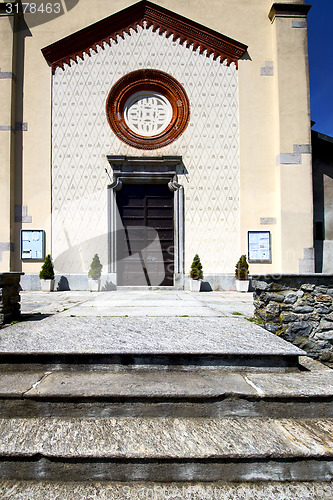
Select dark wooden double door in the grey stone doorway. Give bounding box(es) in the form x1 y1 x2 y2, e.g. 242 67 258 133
117 184 174 286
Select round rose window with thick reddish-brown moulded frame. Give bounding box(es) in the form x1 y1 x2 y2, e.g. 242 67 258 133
106 69 190 149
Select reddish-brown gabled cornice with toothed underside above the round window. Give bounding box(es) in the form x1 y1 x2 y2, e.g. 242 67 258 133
42 0 247 71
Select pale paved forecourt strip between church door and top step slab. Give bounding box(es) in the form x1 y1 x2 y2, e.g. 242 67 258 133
21 290 254 318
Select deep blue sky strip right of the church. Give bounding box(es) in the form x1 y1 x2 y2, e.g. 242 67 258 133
305 0 333 137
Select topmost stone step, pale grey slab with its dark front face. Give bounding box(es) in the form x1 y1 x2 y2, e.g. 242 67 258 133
0 314 305 371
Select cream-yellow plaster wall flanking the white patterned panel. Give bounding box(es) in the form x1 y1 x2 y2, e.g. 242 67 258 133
0 0 313 273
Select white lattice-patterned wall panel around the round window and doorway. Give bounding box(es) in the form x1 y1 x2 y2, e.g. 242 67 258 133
52 27 239 274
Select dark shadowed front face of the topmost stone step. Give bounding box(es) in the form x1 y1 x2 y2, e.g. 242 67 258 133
0 353 300 373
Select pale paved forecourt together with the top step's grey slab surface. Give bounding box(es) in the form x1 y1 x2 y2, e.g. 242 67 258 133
0 290 305 366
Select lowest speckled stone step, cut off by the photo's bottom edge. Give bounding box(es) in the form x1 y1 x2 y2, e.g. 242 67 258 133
0 481 333 500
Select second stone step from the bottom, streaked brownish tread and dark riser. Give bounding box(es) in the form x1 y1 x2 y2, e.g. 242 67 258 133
0 417 333 481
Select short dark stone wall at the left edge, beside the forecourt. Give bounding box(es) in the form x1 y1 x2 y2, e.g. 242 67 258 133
0 273 24 325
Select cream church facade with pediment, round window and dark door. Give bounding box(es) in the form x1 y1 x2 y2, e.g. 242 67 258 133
0 0 315 289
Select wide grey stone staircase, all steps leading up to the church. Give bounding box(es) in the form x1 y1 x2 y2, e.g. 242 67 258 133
0 315 333 499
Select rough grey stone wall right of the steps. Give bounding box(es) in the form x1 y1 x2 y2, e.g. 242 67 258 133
252 274 333 363
